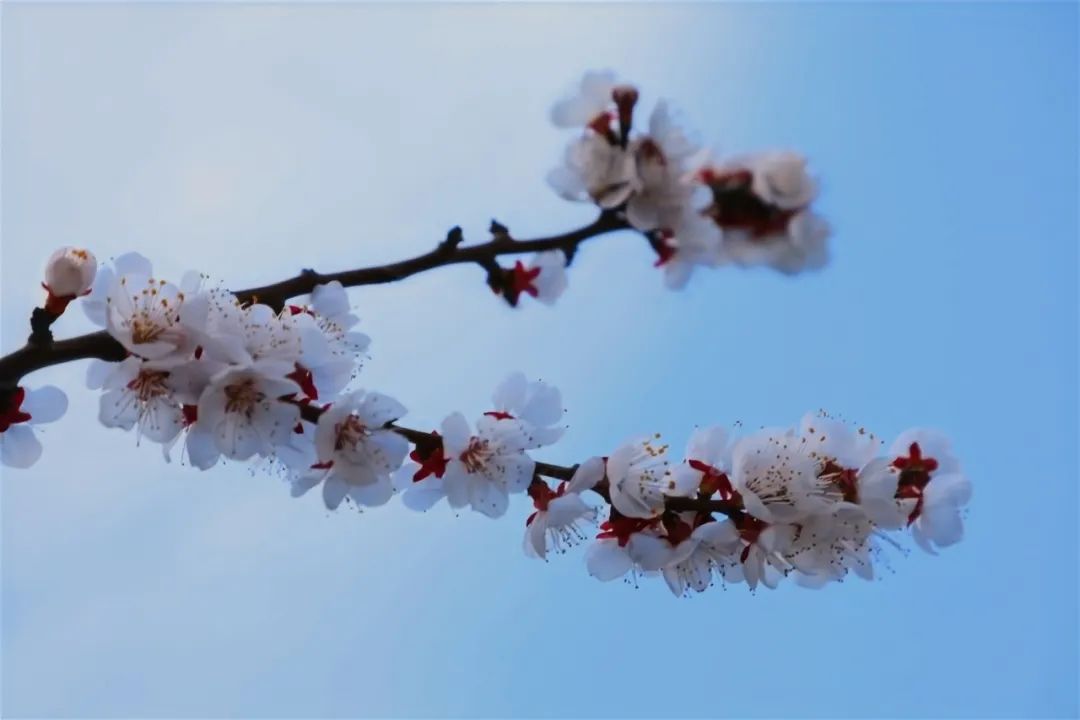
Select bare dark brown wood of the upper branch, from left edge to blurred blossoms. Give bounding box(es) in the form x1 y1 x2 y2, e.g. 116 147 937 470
0 210 631 393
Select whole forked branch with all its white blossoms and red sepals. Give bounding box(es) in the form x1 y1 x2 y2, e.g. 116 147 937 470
0 72 971 595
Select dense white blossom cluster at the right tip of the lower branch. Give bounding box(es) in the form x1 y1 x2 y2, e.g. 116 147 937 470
588 415 971 595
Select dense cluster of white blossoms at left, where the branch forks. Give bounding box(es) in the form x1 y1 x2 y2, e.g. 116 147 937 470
83 253 382 479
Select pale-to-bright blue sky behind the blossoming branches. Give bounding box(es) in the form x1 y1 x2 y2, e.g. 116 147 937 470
0 2 1078 717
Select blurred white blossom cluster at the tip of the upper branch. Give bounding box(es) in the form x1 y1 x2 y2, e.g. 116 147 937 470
548 71 829 288
